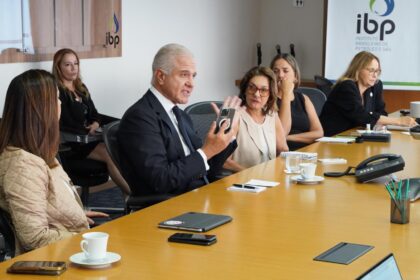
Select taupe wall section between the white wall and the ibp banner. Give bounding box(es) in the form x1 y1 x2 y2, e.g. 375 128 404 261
259 0 324 79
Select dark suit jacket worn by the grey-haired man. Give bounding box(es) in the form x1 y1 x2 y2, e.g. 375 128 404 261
117 91 237 196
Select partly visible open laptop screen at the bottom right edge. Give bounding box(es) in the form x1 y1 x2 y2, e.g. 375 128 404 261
356 253 403 280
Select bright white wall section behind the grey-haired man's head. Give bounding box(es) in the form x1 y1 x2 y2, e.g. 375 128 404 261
0 0 259 117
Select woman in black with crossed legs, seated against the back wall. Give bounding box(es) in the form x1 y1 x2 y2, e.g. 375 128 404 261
52 49 131 196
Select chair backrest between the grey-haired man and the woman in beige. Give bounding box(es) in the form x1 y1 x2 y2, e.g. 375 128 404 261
184 101 223 140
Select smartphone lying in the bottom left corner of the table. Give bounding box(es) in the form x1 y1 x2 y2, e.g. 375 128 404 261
7 261 67 275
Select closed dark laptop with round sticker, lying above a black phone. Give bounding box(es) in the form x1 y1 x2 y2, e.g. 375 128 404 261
158 212 232 232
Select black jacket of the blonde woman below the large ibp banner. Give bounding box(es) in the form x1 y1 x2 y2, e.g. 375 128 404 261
319 80 387 136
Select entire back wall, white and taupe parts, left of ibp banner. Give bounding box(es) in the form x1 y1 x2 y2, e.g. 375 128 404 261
0 0 323 117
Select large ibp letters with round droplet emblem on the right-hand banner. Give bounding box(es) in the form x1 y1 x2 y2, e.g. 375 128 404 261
357 0 395 41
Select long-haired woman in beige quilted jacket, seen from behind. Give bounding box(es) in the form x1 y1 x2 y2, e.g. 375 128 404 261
0 70 107 254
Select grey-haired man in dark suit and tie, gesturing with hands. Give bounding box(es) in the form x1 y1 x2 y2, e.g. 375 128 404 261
117 44 240 196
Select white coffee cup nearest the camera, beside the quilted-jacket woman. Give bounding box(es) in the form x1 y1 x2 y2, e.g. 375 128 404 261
80 232 109 260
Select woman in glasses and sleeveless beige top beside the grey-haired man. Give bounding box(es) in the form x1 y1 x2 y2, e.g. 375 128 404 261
224 67 289 172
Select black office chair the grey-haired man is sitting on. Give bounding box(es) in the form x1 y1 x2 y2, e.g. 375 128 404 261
103 121 173 213
